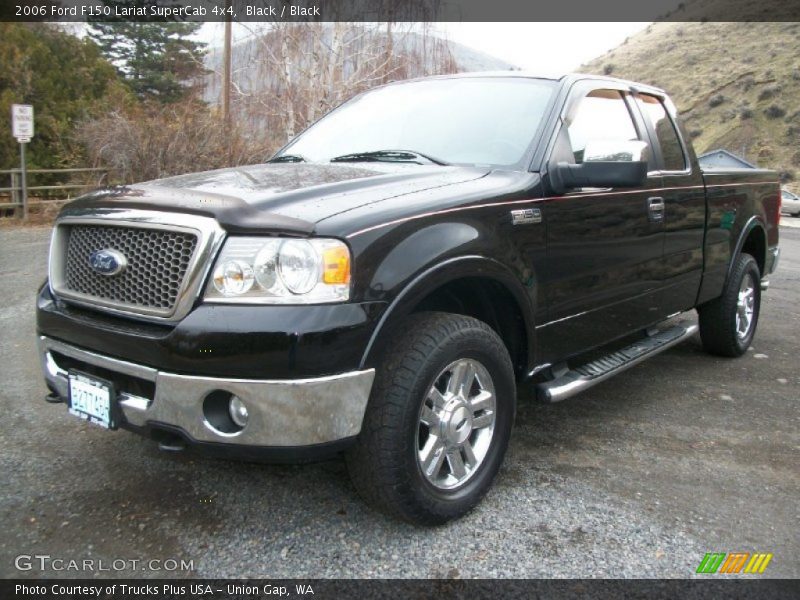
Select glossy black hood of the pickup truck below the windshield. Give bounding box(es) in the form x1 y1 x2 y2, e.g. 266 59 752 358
67 162 490 234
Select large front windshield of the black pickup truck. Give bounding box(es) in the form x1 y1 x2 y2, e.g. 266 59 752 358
281 77 556 165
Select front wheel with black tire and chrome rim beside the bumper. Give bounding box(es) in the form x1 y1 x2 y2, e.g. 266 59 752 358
346 313 516 525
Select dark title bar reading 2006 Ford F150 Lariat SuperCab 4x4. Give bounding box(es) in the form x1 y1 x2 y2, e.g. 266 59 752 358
0 0 800 22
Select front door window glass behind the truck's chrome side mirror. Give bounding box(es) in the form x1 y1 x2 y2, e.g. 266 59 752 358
567 90 639 163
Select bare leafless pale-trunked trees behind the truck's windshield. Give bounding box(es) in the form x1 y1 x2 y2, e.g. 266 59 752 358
216 21 457 142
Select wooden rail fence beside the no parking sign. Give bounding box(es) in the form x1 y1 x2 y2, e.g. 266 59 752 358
0 167 111 218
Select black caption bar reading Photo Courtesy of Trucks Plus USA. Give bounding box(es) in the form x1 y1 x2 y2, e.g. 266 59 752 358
0 578 800 600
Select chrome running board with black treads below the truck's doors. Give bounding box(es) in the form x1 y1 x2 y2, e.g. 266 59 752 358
535 323 698 402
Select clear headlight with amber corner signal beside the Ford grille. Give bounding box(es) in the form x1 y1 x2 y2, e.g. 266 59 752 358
205 237 350 304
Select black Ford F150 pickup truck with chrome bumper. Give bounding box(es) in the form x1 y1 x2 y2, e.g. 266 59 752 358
37 73 780 524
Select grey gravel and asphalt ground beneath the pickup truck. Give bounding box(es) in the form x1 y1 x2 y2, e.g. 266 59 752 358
0 223 800 577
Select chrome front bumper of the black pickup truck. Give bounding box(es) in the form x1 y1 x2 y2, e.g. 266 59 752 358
38 336 375 447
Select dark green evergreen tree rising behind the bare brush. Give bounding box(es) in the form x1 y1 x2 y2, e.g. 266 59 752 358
89 0 205 103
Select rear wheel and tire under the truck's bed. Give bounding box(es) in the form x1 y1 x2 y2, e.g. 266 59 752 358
697 254 761 357
